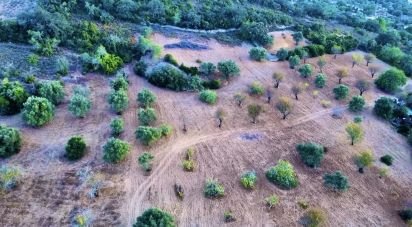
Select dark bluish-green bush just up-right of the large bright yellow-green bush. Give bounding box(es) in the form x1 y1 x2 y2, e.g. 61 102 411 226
296 143 325 168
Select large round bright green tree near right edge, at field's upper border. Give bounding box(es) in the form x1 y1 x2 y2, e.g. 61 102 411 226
375 68 407 93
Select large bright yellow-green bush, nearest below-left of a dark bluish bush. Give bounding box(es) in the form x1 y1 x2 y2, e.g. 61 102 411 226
266 160 299 189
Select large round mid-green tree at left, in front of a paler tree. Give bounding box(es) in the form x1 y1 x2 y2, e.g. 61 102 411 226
22 96 54 127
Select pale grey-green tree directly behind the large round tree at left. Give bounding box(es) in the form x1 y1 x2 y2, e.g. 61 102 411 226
37 80 64 105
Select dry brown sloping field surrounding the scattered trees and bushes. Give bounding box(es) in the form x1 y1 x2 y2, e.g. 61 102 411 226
0 33 412 226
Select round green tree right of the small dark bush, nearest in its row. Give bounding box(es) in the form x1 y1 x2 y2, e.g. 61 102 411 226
103 137 130 163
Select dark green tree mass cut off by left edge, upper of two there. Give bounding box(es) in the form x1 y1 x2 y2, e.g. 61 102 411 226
0 78 29 115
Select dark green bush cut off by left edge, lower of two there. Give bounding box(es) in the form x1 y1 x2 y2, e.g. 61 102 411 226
0 125 21 158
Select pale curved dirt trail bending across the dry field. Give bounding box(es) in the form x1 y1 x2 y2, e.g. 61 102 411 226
127 106 347 226
